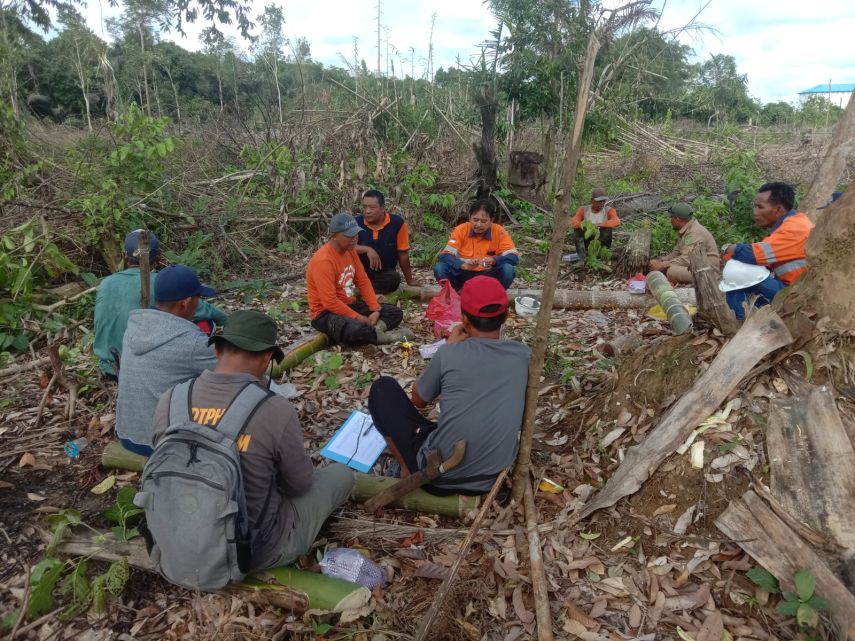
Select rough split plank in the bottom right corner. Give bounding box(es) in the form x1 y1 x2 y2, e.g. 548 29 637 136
715 491 855 639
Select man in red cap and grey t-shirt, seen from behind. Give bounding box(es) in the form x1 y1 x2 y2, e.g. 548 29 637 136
368 276 531 494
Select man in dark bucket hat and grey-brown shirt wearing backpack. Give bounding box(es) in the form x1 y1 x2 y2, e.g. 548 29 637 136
154 310 354 569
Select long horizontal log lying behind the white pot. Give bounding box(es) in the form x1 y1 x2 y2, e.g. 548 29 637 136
403 285 695 309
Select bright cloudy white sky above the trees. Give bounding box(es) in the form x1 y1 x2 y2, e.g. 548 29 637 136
84 0 855 102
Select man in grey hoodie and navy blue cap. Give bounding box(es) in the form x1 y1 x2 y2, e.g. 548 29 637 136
116 265 217 456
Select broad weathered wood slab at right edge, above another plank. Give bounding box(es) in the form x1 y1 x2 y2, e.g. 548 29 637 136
766 387 855 591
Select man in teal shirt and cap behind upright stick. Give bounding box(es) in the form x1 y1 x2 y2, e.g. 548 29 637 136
92 229 227 380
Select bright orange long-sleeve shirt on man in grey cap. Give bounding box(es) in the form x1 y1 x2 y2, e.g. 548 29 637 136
306 243 380 320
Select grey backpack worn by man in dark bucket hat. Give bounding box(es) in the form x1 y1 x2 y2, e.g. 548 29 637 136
134 381 273 591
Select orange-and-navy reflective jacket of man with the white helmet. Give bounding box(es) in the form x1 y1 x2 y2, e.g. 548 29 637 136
724 209 813 285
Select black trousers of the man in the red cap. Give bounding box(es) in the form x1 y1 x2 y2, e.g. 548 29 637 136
368 376 482 496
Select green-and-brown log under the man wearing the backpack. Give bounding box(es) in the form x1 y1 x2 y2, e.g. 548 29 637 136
48 532 371 613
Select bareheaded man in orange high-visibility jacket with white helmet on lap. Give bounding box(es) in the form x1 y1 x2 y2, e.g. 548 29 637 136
722 182 813 319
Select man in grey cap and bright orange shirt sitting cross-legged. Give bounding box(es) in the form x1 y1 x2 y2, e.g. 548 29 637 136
306 213 412 346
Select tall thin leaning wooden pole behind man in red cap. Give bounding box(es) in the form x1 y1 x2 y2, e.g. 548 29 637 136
513 33 600 503
